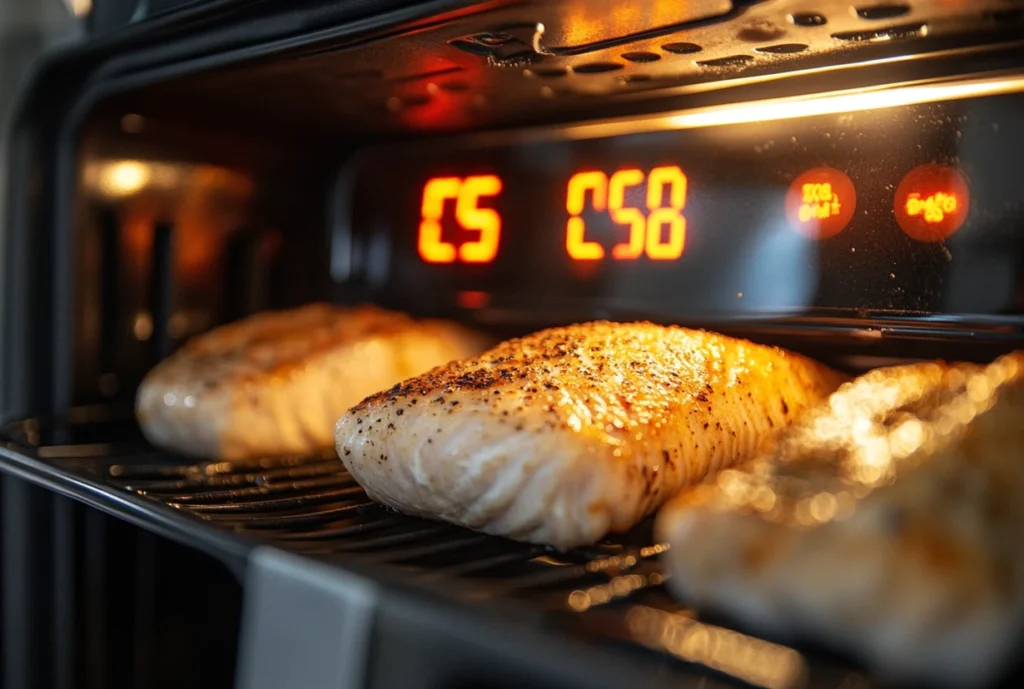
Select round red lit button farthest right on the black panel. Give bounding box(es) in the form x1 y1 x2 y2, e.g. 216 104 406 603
893 163 971 242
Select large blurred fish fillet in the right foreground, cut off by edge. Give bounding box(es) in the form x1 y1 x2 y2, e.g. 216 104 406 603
656 354 1024 686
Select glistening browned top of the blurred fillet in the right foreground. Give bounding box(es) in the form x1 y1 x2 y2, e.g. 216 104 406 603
686 354 1024 528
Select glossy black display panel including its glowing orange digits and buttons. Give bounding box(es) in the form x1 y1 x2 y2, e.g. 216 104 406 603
351 82 1024 317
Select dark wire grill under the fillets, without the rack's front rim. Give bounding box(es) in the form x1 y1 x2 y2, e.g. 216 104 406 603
4 414 873 689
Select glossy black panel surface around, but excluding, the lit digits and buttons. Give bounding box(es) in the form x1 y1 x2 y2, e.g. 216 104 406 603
351 89 1024 319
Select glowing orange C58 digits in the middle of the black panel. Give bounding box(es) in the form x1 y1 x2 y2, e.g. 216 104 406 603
565 166 687 261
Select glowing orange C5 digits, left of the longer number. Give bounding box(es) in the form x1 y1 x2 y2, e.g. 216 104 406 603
417 175 502 263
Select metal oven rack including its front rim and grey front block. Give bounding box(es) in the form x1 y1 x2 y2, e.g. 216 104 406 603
0 411 872 689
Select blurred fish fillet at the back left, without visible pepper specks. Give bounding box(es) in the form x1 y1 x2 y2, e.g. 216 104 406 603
136 304 484 460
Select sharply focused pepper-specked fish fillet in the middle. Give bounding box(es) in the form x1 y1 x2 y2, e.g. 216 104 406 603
336 322 841 548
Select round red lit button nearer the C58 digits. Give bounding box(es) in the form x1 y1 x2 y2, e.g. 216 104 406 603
785 167 857 240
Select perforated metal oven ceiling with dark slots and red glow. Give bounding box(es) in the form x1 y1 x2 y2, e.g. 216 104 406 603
132 0 1024 132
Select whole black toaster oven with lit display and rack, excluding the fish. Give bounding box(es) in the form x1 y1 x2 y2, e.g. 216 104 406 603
0 0 1024 689
